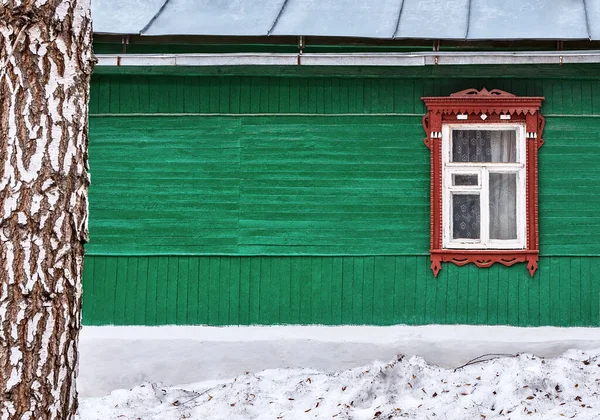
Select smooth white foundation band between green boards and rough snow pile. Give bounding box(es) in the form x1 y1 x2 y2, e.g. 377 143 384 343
78 325 600 398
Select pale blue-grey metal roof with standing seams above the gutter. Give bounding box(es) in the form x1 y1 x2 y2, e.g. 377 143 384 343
92 0 600 40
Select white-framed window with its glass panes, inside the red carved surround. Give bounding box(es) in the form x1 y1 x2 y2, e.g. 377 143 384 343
442 124 526 249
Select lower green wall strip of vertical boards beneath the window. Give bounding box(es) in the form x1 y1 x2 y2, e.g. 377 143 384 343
83 256 600 326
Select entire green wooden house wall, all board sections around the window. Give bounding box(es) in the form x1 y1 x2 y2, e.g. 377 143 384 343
84 67 600 325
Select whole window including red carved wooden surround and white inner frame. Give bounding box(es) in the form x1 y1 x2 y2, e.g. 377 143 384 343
423 89 544 276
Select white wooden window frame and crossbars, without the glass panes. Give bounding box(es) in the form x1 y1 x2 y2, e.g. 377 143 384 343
442 123 527 250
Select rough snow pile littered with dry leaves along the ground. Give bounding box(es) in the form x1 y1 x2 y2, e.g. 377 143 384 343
80 350 600 420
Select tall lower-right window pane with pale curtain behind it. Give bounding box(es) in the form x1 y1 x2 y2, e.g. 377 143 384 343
490 173 517 239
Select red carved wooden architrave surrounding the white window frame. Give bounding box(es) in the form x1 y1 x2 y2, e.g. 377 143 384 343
421 88 544 277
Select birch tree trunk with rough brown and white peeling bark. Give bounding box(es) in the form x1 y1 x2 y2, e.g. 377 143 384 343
0 0 93 420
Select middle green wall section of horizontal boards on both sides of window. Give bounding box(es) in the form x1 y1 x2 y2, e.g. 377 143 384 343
88 111 600 256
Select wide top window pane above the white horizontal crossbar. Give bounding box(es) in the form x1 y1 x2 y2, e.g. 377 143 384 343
452 130 517 163
